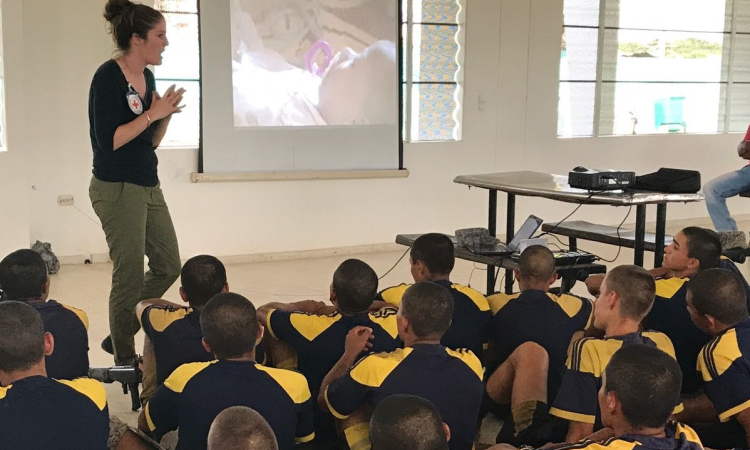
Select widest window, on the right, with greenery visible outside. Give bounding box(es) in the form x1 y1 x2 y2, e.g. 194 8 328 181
557 0 750 137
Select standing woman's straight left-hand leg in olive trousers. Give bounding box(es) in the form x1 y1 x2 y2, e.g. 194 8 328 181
89 178 148 364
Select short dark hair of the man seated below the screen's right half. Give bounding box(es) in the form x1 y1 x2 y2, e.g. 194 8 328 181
333 259 378 313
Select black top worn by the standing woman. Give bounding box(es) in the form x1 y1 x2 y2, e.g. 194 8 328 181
89 60 159 187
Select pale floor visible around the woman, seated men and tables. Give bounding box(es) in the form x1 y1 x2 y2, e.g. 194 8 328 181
44 220 750 442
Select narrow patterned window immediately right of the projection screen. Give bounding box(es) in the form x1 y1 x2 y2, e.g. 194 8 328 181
401 0 466 142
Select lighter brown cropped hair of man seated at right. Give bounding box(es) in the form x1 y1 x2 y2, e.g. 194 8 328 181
606 265 656 322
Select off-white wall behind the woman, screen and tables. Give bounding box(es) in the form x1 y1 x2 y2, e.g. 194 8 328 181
0 0 750 257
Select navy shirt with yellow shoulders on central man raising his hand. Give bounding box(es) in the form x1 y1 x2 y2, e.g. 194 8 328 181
325 344 483 450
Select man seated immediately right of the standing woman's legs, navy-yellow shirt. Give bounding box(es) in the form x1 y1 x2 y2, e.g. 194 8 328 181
135 255 229 404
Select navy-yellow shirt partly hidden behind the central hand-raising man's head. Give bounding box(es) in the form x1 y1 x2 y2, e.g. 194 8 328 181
378 280 492 358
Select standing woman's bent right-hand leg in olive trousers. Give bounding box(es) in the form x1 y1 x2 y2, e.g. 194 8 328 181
140 186 182 300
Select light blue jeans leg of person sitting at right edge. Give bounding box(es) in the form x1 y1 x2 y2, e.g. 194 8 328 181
703 166 750 231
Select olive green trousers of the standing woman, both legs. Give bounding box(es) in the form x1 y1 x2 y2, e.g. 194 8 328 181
89 177 180 364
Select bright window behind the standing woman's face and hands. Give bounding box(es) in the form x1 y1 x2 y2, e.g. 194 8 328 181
154 0 201 148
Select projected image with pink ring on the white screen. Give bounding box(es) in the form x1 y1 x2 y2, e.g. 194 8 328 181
230 0 399 127
